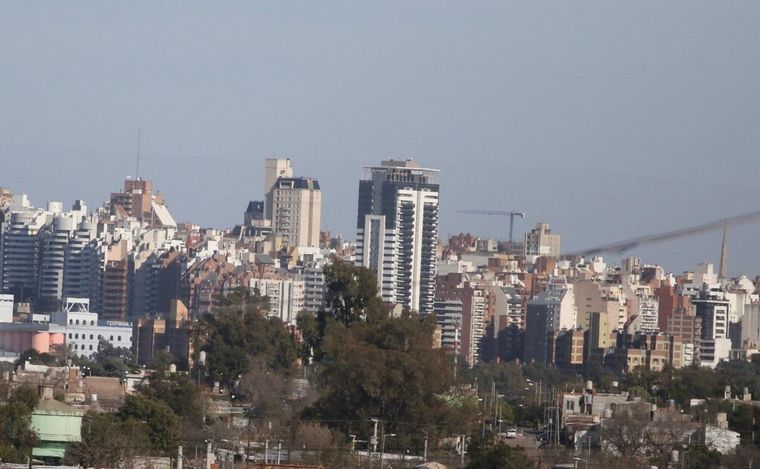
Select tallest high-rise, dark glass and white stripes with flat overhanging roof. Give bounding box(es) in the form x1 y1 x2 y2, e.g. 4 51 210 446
356 160 439 314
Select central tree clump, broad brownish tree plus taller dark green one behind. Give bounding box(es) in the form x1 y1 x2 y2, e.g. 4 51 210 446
306 262 477 444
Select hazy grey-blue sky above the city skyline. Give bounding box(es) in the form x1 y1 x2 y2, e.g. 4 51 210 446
0 0 760 275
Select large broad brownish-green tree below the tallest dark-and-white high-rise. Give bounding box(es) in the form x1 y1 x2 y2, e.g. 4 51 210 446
306 313 477 438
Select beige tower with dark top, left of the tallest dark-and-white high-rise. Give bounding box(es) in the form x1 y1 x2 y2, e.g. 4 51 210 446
268 177 322 247
